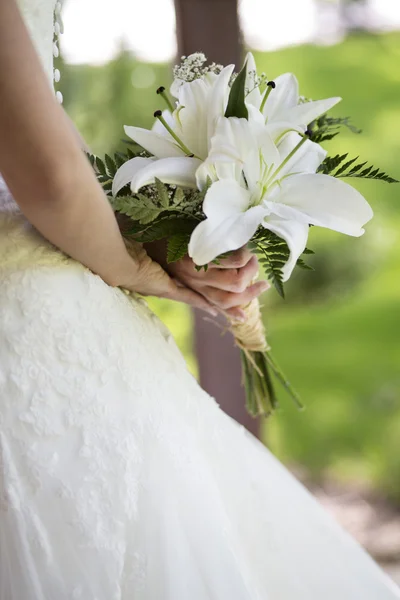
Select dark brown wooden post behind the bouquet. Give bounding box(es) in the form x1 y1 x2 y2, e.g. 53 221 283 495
175 0 259 435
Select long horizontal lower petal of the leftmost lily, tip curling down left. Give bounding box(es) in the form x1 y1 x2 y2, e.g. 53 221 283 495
131 156 201 193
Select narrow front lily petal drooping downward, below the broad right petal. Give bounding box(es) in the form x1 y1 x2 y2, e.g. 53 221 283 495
263 215 309 281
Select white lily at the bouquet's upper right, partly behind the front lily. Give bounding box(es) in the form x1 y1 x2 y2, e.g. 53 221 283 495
246 52 341 132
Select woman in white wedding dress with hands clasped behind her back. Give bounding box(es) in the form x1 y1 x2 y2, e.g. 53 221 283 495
0 0 400 600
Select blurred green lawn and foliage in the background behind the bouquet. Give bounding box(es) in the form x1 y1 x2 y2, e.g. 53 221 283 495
61 32 400 504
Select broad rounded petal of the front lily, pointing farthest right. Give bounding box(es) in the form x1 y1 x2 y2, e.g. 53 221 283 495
269 173 373 237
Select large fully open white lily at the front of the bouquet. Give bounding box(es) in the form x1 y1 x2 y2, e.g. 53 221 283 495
189 118 373 281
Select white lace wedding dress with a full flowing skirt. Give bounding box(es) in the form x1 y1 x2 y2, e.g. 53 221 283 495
0 0 400 600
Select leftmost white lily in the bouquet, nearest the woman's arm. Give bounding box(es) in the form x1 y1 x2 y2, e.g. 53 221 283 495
113 65 234 195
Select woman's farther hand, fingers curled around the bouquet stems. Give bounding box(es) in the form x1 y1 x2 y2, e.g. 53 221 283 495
142 243 269 320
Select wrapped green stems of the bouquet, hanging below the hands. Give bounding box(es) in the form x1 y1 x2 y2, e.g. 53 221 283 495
229 298 302 416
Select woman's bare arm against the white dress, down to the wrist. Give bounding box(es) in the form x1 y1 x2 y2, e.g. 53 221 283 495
0 0 135 285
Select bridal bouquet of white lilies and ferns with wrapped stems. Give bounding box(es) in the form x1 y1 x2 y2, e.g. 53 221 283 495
90 53 395 415
